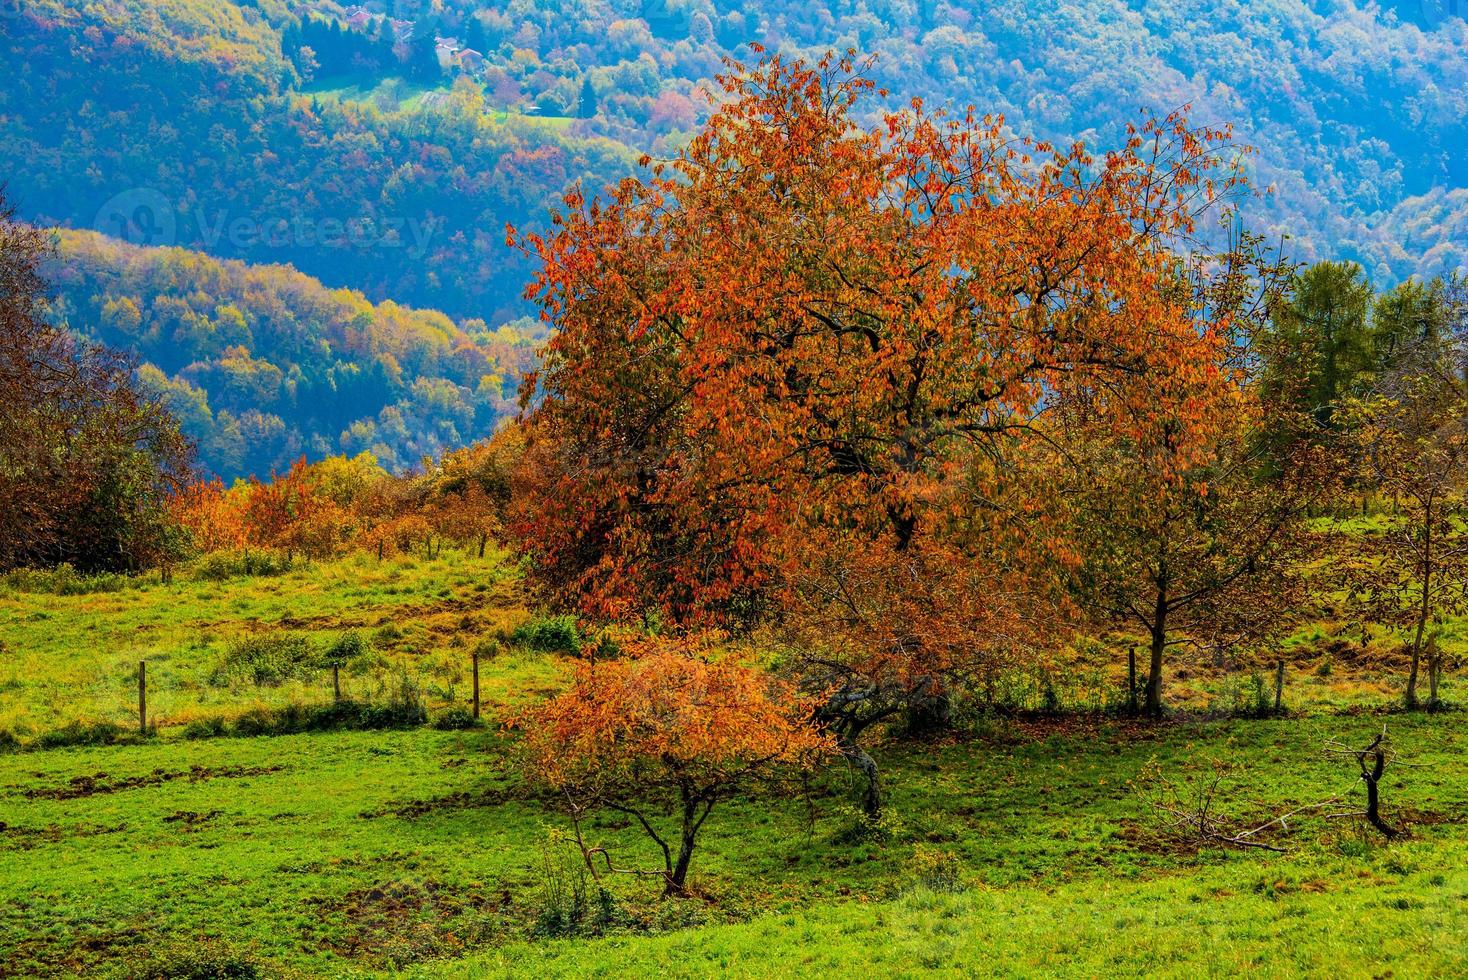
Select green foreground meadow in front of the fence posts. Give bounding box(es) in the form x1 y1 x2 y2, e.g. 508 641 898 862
0 716 1468 976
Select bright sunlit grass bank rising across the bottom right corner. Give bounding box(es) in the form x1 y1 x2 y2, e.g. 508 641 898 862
449 842 1468 977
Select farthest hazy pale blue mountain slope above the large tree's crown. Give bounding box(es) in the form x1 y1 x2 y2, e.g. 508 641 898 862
390 0 1468 285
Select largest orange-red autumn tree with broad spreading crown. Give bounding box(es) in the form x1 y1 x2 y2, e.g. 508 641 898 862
511 47 1262 808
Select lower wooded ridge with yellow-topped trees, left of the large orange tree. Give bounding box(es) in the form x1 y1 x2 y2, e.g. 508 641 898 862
46 230 534 478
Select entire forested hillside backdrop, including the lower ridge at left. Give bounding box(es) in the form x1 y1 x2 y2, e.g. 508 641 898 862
0 0 1468 475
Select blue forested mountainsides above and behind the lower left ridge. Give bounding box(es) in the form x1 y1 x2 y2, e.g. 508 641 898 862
0 0 1468 303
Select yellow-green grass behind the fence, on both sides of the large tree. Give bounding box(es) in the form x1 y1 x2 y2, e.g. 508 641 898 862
0 550 1444 738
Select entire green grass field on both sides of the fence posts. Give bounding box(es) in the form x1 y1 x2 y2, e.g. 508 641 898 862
0 555 1468 977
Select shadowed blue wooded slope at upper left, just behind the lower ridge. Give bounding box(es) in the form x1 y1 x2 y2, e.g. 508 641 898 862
0 0 634 323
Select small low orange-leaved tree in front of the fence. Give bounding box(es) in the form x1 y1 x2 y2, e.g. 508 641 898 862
515 638 831 895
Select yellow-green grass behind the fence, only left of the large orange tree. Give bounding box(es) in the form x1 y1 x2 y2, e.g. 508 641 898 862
0 549 534 735
